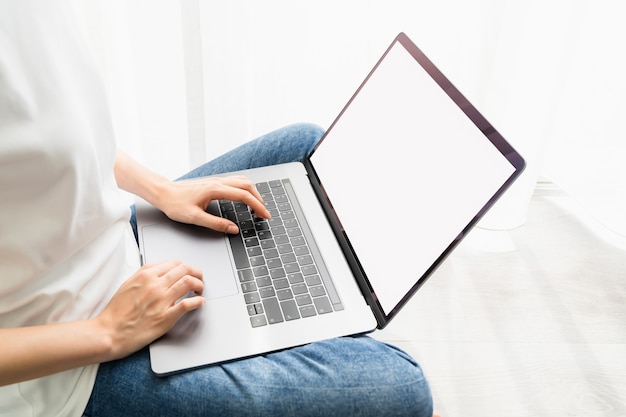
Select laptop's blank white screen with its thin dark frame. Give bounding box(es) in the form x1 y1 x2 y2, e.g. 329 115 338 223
310 34 523 320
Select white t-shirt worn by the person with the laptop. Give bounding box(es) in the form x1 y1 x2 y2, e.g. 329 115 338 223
0 0 139 417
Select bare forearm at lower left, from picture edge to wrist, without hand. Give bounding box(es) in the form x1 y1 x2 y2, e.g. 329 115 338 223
0 320 113 386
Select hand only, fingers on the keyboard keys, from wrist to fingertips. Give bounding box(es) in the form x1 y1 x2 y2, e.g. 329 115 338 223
152 176 270 234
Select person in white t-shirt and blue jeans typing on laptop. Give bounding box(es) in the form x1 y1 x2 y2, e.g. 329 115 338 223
0 0 432 417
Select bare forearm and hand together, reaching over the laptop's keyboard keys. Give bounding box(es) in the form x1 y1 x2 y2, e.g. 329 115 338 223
115 151 270 233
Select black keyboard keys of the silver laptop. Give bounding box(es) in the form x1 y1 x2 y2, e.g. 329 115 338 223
214 179 343 327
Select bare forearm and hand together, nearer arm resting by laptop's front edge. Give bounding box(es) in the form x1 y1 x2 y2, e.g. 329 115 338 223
0 261 204 386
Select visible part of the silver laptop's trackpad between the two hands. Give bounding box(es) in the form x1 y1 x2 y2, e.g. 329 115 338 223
142 222 238 299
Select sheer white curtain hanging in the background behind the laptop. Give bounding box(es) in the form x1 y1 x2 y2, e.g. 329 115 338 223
77 0 626 237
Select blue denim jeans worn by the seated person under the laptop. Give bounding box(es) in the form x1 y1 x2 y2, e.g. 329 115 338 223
85 124 432 417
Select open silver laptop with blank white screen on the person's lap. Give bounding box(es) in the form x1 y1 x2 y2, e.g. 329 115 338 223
136 33 524 375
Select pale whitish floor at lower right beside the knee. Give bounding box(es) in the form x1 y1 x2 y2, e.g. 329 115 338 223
374 186 626 417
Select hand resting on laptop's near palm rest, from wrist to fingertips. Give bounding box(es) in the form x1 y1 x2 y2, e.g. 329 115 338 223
95 261 204 359
